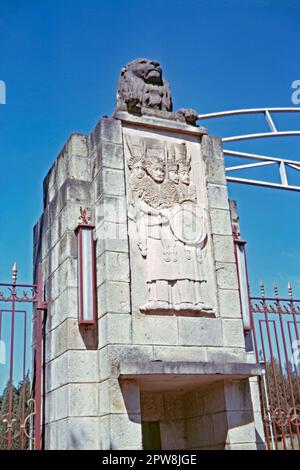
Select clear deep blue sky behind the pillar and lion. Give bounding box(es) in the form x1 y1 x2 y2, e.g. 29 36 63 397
0 0 300 297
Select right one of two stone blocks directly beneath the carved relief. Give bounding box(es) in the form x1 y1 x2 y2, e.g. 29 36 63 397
178 317 223 346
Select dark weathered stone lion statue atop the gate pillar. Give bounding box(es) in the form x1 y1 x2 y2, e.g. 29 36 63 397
116 59 197 125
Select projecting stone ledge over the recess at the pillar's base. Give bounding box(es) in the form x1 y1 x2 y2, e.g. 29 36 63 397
119 361 261 391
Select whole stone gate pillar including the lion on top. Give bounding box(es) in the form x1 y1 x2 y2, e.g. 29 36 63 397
35 59 264 450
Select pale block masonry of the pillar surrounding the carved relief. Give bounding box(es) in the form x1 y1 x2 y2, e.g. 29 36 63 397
34 118 259 449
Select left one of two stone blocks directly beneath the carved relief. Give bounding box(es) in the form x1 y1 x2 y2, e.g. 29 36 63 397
132 315 178 345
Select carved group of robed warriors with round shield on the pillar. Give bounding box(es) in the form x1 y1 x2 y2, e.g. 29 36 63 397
126 138 212 313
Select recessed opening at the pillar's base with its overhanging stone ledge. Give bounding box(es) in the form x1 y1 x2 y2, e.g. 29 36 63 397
115 361 264 450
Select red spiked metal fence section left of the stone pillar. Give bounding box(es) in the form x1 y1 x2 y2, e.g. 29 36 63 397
0 265 47 450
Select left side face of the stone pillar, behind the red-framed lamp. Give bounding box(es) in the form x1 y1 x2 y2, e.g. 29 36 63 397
34 134 99 449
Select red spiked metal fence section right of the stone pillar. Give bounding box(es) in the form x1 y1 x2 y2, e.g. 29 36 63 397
250 284 300 450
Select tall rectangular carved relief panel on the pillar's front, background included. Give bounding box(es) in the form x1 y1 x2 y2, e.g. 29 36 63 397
124 130 214 316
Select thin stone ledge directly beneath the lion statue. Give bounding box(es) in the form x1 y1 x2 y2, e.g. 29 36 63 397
114 111 207 137
